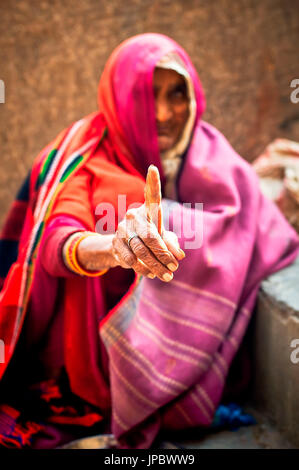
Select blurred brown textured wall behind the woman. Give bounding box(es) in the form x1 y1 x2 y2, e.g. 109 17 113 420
0 0 299 228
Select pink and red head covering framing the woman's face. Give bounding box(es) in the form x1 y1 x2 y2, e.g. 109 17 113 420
98 33 205 182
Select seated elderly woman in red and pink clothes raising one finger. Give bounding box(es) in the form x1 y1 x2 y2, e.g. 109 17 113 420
0 34 299 448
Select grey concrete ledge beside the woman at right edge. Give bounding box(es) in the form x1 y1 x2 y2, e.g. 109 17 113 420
253 258 299 447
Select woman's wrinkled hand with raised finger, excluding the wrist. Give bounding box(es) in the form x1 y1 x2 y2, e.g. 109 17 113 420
112 165 185 282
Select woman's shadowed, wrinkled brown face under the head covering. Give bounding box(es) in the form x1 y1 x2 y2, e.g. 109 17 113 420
154 67 189 152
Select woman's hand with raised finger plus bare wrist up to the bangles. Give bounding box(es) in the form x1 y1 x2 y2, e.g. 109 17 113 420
73 165 185 282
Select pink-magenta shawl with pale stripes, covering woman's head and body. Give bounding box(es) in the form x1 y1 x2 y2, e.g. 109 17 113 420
95 34 299 447
